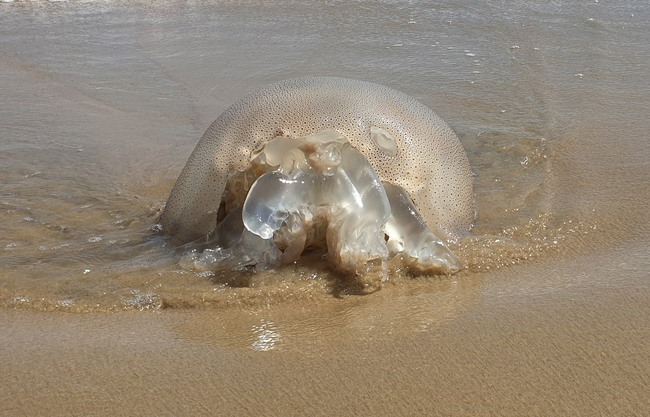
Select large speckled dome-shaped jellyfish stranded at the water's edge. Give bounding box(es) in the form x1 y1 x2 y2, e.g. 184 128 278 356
160 77 474 275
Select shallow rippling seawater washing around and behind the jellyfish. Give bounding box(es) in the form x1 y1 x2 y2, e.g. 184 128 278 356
0 1 650 316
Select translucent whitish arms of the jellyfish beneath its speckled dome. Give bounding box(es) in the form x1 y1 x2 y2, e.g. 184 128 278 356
184 130 459 275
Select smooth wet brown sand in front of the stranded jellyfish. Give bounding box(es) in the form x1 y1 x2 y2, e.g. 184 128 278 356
0 239 650 416
